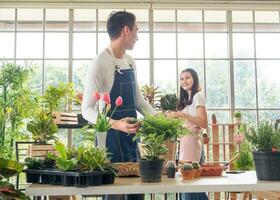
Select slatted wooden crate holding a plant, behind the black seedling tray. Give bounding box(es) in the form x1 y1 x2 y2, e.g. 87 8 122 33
27 144 54 158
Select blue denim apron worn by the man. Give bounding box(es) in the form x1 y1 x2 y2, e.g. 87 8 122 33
105 49 144 200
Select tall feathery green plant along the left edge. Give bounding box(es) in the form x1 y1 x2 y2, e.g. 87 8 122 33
0 62 36 157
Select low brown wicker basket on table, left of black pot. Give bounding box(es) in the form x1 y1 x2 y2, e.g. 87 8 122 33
113 162 140 176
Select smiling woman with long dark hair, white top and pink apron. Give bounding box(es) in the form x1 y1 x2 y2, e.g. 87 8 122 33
167 68 208 200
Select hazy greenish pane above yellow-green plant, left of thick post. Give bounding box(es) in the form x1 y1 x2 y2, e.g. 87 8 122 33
45 60 68 88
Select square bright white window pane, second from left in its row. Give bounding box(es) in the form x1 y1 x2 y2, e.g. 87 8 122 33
16 33 43 58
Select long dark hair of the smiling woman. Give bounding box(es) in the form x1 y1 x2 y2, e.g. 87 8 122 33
178 68 199 110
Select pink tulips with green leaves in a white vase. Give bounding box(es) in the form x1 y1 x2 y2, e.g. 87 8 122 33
93 92 123 148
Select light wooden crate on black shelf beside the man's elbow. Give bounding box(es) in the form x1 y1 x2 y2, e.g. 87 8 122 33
52 111 78 124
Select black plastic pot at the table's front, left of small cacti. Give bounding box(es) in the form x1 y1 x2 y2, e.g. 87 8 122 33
138 159 164 182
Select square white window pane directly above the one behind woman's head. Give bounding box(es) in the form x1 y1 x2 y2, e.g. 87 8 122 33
178 33 203 58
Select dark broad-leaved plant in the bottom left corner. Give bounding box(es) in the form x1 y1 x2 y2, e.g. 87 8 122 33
0 158 30 200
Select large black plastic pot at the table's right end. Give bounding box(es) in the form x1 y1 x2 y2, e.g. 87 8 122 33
253 151 280 181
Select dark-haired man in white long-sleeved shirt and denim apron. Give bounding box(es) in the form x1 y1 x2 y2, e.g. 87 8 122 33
82 11 156 200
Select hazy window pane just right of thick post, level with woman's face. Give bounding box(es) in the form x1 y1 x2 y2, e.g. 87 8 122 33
234 60 256 108
